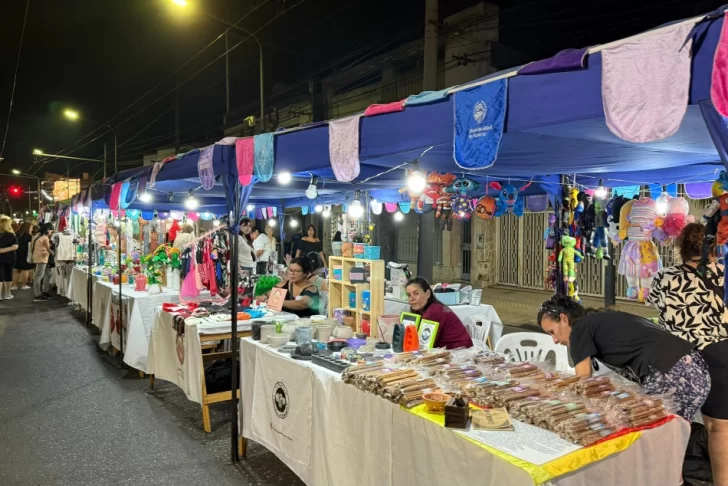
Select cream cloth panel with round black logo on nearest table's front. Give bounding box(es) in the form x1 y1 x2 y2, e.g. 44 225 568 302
251 349 314 466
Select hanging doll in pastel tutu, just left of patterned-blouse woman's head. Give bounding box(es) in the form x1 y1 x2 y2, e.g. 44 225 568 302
617 198 664 302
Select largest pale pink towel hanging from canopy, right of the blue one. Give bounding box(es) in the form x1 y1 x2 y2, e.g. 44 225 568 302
602 23 694 143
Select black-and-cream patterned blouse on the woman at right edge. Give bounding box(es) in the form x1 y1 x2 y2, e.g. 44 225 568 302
647 263 728 349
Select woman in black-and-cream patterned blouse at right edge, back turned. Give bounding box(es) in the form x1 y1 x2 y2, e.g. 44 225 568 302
647 223 728 486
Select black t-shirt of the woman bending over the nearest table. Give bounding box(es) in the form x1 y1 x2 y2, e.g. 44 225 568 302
569 312 695 379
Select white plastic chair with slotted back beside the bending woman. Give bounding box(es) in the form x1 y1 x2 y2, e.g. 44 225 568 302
495 332 572 371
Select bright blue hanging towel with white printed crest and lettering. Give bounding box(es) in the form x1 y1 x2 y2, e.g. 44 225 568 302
453 79 508 169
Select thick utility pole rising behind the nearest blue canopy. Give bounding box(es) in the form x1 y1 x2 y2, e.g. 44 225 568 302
417 0 438 281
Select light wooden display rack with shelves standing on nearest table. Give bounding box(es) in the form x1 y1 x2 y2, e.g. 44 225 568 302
329 256 384 337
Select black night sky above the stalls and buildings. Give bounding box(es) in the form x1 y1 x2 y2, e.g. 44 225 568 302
0 0 723 203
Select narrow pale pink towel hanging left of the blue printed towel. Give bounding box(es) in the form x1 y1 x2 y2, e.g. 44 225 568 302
329 115 361 182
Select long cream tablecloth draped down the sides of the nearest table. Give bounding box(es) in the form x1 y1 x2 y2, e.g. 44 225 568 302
240 338 690 486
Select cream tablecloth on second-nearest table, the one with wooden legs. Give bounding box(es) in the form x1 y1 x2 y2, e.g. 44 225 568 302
149 306 297 403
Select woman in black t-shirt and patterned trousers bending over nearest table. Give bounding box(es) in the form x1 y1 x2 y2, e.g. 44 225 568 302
538 295 710 421
